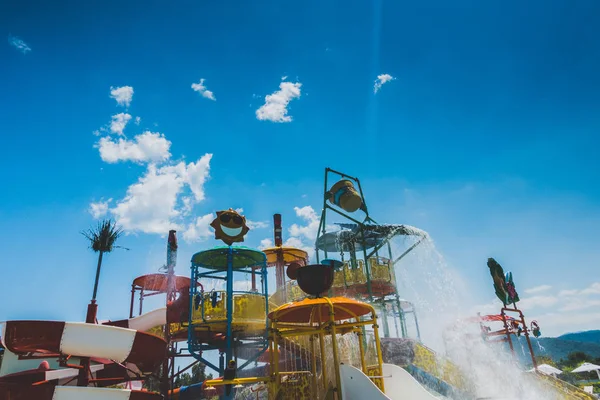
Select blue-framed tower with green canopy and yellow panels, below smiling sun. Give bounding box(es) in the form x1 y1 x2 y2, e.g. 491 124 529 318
188 246 269 398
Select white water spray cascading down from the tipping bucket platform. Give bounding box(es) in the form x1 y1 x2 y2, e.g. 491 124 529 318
393 238 558 400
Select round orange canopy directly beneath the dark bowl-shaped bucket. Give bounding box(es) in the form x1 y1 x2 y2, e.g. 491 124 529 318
269 297 375 323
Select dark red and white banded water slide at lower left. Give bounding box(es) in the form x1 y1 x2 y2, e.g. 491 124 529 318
0 320 166 400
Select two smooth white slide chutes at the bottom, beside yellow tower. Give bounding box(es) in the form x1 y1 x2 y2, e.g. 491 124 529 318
340 364 439 400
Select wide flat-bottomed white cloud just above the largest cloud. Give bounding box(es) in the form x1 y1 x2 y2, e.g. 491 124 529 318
95 131 171 163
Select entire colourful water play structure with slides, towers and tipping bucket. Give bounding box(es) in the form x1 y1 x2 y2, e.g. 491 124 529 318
0 168 586 400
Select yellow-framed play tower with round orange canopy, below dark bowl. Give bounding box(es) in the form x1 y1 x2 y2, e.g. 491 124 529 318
205 297 384 400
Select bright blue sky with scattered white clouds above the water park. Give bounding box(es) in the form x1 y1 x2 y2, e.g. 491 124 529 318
0 0 600 344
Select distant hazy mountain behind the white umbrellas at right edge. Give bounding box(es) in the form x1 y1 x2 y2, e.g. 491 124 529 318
508 331 600 365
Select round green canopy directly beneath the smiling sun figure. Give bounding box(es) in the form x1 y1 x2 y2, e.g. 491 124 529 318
192 246 266 270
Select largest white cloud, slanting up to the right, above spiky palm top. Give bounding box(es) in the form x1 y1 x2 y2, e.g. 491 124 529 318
110 154 212 234
